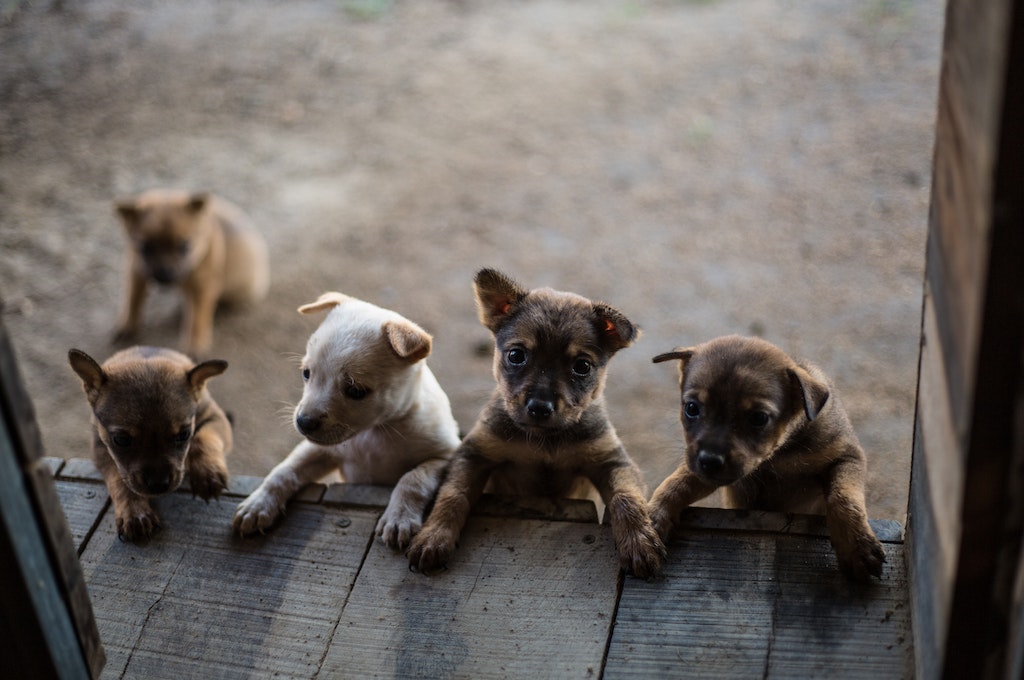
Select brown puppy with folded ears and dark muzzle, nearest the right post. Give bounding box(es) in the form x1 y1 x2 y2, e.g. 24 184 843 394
650 336 886 581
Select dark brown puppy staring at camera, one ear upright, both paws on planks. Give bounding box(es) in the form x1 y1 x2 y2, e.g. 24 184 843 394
408 269 665 578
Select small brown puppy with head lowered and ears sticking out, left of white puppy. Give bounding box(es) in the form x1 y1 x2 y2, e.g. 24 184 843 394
68 347 231 542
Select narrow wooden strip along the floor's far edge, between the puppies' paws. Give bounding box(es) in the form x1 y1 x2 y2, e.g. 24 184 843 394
45 458 905 544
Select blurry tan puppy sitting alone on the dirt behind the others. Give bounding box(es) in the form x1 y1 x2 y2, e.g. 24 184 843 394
115 189 270 356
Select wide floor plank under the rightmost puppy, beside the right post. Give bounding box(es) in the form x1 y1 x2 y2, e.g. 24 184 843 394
604 532 913 679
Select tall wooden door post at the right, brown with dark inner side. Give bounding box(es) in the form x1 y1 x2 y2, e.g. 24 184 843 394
908 0 1024 678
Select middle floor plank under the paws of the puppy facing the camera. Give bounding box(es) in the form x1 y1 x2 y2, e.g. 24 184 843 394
321 516 618 678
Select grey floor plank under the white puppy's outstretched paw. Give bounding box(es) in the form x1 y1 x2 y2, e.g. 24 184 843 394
82 494 377 679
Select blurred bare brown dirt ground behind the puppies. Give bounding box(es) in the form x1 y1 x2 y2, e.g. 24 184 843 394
0 0 942 520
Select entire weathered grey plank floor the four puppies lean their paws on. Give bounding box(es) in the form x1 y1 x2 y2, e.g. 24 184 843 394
50 460 913 680
